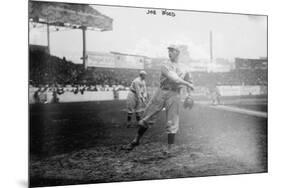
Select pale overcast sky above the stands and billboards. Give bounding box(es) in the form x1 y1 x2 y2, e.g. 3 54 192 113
30 5 267 63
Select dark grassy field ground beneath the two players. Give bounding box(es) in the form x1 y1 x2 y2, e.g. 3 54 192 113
30 101 267 186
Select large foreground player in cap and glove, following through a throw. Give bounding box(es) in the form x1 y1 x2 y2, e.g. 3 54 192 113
126 45 193 153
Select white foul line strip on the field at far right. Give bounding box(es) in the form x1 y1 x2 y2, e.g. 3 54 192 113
210 105 267 118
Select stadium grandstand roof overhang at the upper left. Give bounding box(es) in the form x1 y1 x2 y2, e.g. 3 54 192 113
29 1 113 31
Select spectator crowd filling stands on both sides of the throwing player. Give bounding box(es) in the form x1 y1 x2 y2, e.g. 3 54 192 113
29 50 267 98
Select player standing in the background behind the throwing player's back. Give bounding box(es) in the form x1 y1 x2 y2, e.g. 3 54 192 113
127 70 147 128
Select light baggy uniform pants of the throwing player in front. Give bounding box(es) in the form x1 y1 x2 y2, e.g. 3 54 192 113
142 88 180 134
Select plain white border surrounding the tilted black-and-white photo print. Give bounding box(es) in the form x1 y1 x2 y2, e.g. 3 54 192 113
0 0 281 188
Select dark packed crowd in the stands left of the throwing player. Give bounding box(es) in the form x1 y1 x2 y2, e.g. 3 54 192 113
29 50 160 90
